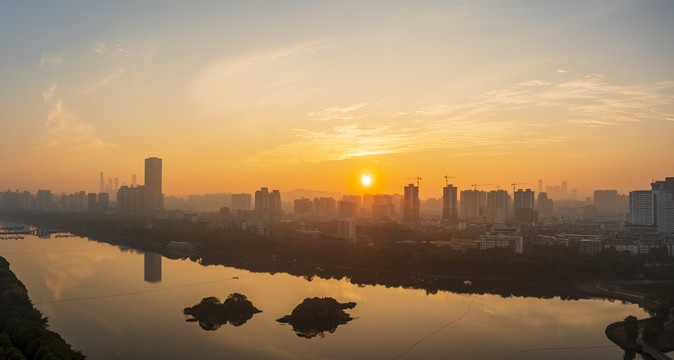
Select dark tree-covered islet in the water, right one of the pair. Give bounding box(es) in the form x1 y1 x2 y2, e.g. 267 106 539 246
276 297 356 339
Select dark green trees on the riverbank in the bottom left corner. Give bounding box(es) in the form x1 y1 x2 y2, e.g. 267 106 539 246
0 257 84 359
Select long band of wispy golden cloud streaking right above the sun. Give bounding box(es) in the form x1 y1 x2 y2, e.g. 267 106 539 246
244 75 674 166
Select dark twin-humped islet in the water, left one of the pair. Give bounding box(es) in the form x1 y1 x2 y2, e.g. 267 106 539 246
183 293 262 331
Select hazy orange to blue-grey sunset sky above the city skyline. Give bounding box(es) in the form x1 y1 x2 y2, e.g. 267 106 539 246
0 0 674 198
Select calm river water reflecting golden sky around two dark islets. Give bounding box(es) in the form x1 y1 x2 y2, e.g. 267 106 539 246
0 221 660 360
